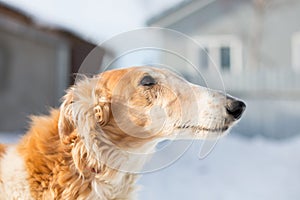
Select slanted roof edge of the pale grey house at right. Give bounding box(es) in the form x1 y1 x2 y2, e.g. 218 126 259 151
147 0 216 27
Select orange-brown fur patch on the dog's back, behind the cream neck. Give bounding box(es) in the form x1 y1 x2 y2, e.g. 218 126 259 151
18 110 89 199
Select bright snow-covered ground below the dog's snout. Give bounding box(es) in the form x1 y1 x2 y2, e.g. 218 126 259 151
0 134 300 200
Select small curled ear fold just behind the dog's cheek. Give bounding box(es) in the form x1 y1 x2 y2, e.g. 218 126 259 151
93 89 110 126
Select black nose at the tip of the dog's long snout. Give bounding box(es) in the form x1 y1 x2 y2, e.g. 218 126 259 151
225 96 246 120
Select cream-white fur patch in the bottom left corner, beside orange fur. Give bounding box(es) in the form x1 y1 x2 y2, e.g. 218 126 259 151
0 146 33 200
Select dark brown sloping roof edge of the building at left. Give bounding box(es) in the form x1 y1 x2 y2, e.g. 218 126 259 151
0 2 95 45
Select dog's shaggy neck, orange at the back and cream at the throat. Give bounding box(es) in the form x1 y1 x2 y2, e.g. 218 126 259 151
19 110 141 199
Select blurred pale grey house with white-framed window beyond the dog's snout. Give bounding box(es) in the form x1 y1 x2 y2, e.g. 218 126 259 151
148 0 300 138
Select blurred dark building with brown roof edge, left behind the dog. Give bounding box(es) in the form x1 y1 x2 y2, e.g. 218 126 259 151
0 4 104 132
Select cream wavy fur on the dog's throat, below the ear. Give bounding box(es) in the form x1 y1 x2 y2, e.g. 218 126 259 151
64 129 144 199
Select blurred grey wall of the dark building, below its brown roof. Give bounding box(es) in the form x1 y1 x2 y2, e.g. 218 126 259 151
0 18 69 131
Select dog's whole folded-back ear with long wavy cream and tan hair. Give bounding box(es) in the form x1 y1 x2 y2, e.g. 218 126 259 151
58 78 110 142
